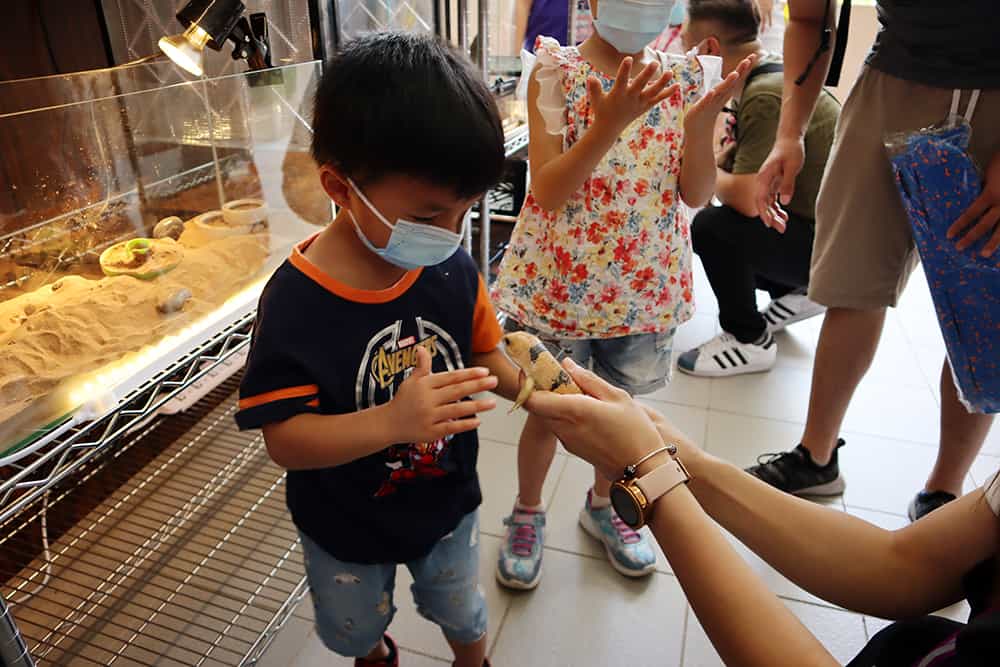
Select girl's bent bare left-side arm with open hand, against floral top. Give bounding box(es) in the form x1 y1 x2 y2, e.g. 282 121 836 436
528 58 676 211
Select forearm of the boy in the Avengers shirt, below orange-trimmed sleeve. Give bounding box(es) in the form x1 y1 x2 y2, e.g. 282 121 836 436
264 404 402 470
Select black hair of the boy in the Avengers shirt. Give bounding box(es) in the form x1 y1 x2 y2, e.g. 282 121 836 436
312 32 505 198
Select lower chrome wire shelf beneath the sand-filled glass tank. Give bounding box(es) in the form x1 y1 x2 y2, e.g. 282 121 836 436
0 380 306 666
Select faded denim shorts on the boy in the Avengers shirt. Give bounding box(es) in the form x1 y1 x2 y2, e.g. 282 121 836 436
299 510 486 658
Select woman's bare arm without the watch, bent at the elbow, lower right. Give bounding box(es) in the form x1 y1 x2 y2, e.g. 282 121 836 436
644 408 1000 618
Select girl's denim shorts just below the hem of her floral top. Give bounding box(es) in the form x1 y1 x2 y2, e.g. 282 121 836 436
504 318 675 396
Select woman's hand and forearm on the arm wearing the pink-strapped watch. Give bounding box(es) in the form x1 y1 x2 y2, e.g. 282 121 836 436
527 363 837 667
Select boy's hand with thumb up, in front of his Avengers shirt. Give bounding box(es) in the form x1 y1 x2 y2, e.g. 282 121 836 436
389 347 497 442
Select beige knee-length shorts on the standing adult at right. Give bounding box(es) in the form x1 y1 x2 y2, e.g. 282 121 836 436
809 67 1000 309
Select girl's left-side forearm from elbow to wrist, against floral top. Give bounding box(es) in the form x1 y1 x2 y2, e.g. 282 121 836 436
531 122 618 211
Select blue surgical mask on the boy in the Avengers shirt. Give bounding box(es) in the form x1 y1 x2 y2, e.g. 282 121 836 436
347 179 471 271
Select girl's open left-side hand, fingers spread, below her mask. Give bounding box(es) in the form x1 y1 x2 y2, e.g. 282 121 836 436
587 58 680 136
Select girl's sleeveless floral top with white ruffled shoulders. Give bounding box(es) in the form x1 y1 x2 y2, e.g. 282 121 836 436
493 38 721 338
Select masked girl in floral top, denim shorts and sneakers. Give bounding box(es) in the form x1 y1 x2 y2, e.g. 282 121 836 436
494 0 752 589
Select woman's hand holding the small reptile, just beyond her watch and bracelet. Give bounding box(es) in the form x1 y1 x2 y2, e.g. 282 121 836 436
525 358 663 479
